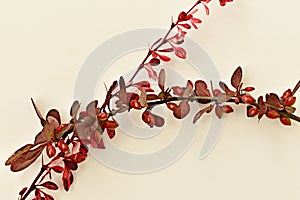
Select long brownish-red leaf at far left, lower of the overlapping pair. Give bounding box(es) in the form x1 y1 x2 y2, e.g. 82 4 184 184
10 145 46 172
